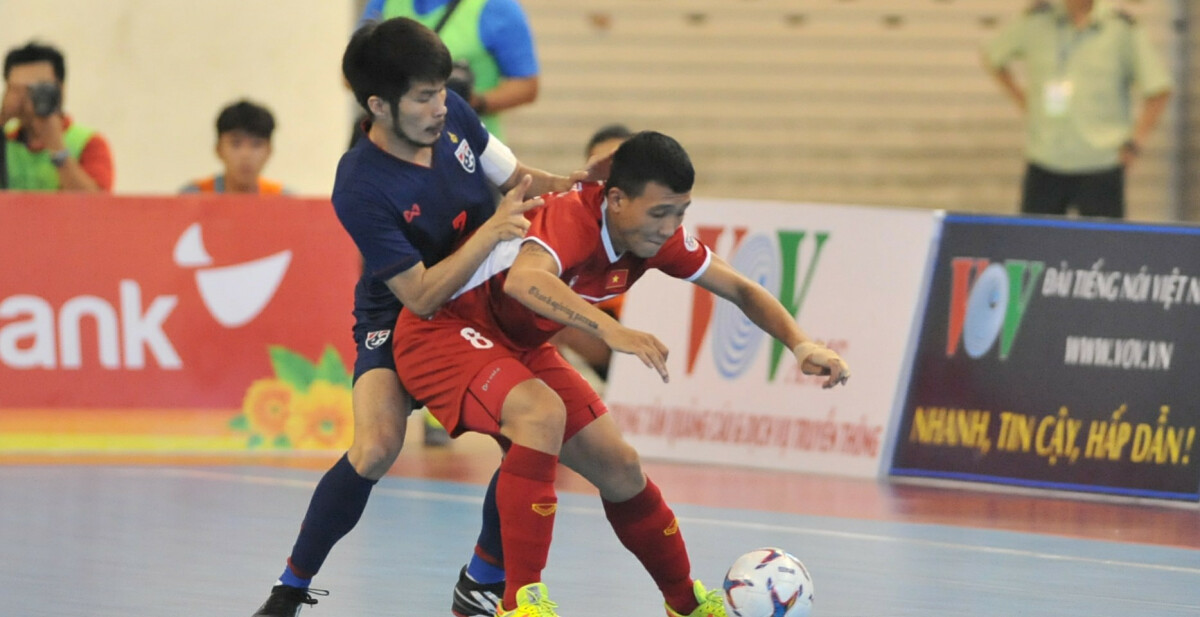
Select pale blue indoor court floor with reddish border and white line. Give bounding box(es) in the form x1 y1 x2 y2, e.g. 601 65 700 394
0 433 1200 617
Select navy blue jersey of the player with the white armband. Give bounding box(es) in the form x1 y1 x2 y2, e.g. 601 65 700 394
332 92 497 322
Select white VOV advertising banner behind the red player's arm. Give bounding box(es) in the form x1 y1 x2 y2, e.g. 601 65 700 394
605 199 936 477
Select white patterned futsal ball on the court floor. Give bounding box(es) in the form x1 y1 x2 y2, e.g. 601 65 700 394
725 549 812 617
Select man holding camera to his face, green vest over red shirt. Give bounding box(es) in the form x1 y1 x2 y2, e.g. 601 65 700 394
0 42 113 192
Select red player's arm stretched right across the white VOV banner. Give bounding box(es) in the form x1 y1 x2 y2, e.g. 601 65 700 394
696 254 850 388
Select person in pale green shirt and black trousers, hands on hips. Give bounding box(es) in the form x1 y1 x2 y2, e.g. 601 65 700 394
983 0 1171 217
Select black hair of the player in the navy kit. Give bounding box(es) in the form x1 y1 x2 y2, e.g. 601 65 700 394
342 17 452 114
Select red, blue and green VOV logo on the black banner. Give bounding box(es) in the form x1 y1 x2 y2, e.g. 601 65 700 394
946 257 1045 360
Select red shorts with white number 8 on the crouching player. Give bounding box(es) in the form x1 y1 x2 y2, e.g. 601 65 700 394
392 311 608 444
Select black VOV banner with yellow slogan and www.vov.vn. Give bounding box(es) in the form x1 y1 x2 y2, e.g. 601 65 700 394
892 215 1200 501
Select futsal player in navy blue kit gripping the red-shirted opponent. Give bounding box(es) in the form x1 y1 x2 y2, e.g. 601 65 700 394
254 18 599 617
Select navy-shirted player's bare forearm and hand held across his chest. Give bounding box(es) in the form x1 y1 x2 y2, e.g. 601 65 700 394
388 176 544 317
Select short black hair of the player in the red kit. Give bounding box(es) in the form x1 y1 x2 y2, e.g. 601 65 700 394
606 131 696 198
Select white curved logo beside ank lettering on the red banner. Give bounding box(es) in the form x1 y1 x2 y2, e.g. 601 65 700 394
174 223 292 328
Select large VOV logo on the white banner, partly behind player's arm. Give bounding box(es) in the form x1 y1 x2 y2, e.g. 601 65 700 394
686 226 829 382
